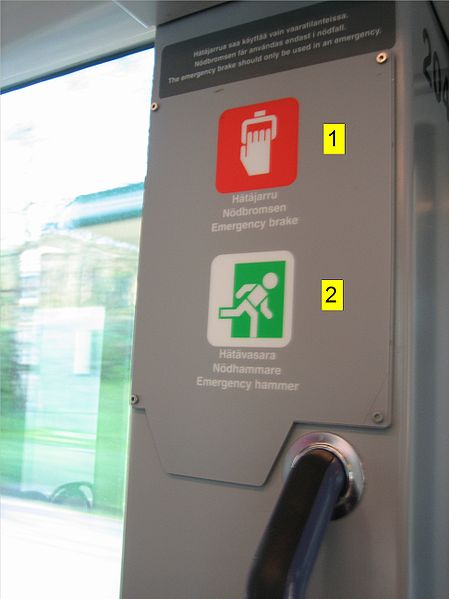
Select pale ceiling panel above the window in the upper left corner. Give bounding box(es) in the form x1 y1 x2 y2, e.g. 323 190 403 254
0 0 221 89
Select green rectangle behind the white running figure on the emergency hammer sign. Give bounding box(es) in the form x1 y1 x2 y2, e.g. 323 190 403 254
231 260 285 339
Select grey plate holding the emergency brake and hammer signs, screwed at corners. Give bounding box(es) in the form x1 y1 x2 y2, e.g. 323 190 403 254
133 10 393 485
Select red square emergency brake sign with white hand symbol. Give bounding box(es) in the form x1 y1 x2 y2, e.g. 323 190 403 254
216 98 299 193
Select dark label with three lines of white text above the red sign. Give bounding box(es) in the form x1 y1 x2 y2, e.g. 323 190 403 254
159 0 395 98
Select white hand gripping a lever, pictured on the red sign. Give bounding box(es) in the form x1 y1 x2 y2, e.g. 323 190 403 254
240 110 277 176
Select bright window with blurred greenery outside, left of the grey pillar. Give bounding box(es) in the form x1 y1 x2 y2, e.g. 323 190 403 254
0 49 153 599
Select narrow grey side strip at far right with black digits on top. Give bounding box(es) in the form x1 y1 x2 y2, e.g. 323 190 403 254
410 2 449 599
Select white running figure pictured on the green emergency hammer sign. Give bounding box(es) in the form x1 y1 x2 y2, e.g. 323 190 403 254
218 272 278 337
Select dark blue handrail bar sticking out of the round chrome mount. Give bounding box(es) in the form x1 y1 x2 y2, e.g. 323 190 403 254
247 449 346 599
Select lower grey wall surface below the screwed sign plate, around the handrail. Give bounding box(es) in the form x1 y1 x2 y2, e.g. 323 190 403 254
122 410 406 599
